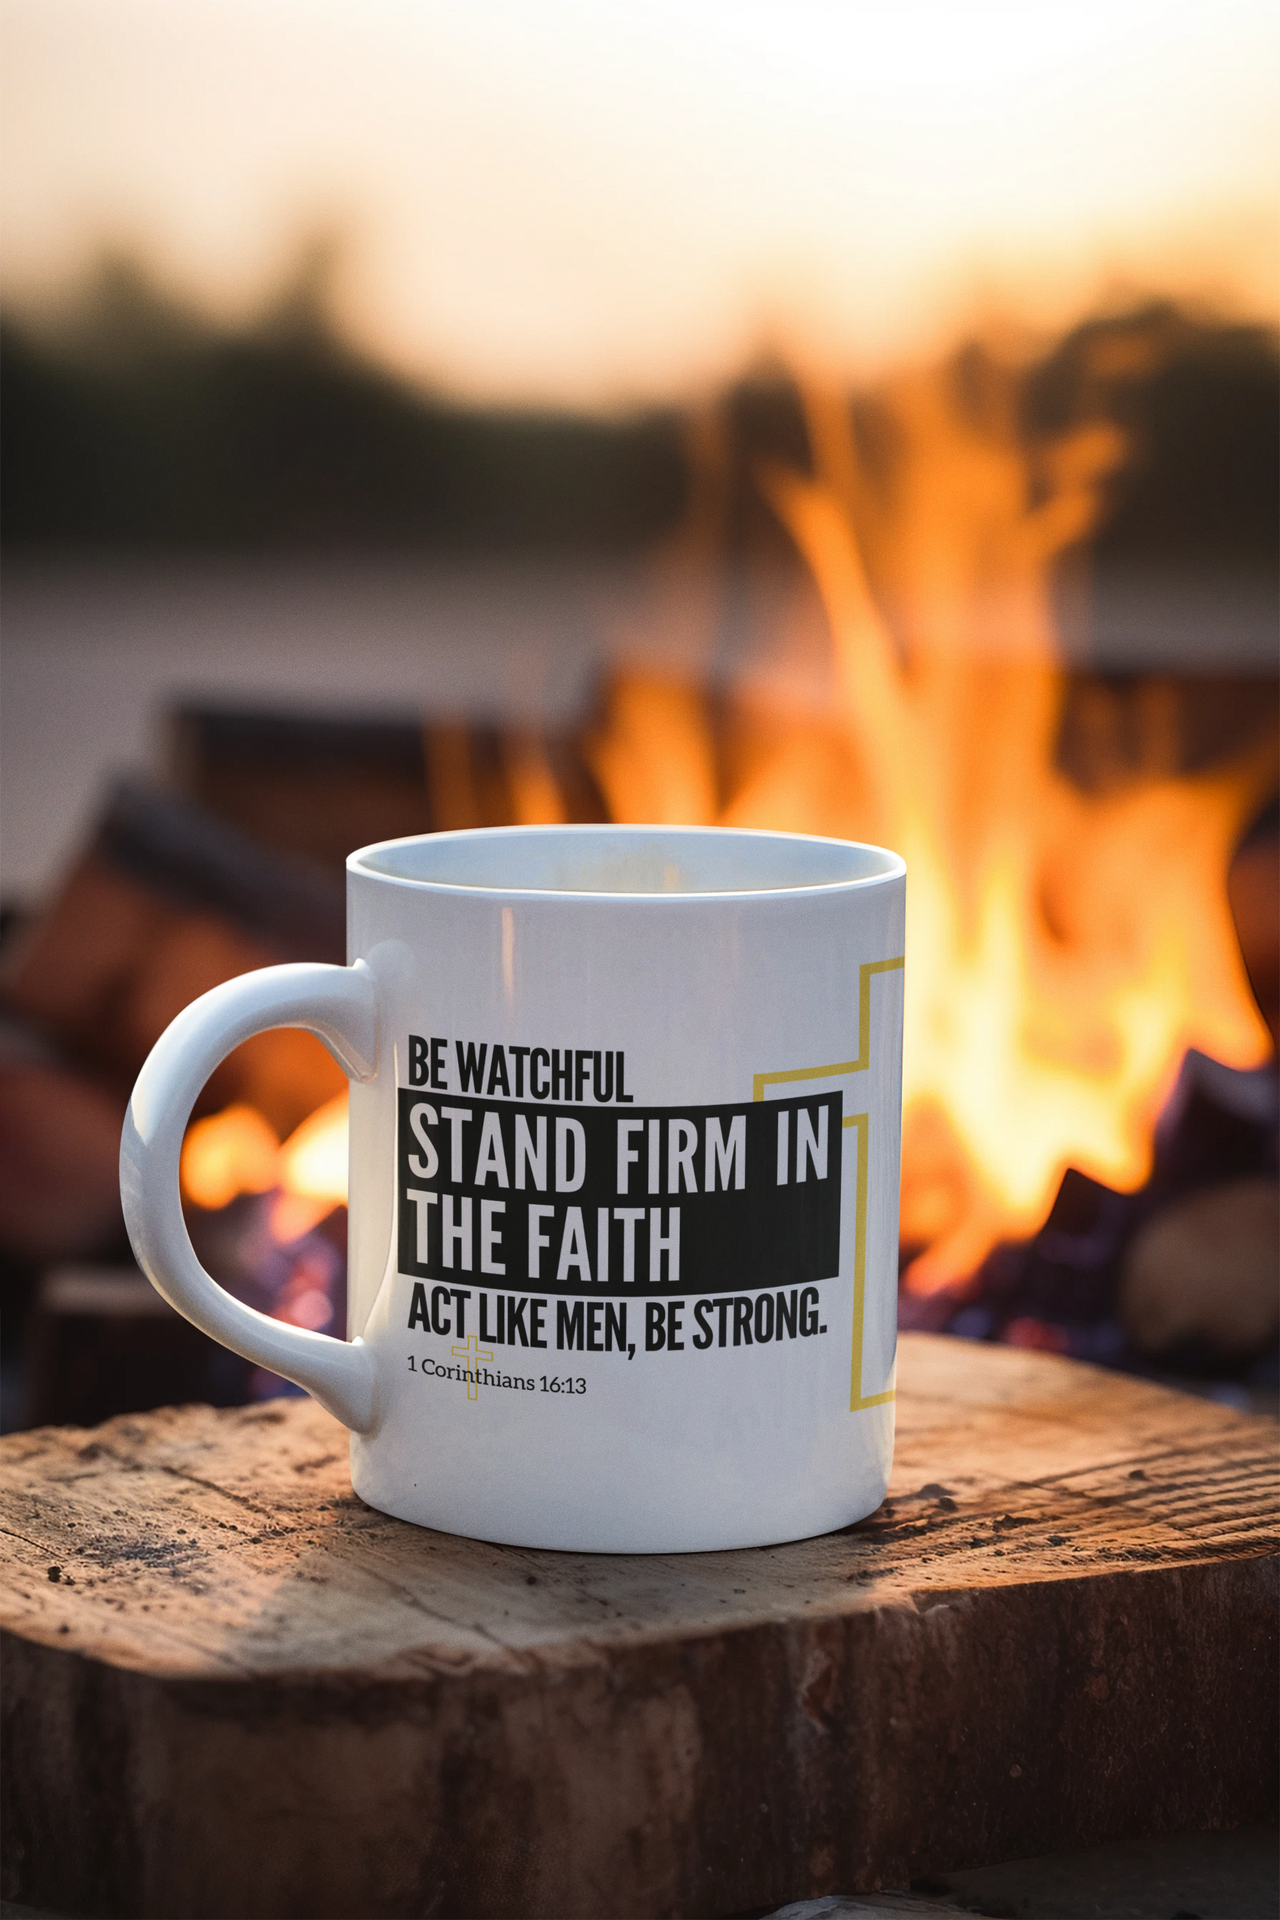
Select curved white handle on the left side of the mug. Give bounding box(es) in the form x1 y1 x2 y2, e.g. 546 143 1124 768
121 960 378 1432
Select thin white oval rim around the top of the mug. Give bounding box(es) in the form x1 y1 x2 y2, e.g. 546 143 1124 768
345 822 906 904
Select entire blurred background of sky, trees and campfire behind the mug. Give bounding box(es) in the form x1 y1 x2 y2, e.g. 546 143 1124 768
0 0 1280 1425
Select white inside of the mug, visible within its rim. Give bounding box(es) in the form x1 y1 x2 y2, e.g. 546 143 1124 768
347 826 904 895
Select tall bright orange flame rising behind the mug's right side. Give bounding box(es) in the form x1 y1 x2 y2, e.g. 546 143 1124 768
591 355 1274 1292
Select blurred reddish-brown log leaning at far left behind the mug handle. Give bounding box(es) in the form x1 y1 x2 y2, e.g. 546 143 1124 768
0 785 344 1261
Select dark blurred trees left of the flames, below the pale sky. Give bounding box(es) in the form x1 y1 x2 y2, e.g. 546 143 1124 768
0 261 687 553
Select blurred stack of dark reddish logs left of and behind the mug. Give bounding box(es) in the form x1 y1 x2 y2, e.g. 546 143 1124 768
0 708 599 1423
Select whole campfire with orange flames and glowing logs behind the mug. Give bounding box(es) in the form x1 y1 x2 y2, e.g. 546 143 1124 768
10 317 1278 1428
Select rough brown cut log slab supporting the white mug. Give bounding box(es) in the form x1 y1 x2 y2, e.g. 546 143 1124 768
0 1334 1278 1916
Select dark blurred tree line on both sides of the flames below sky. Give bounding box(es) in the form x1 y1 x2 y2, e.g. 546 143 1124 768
0 242 1280 582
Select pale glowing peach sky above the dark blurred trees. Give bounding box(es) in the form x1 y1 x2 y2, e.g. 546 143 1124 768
0 0 1280 407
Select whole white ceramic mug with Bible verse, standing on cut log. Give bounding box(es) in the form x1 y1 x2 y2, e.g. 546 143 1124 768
121 826 906 1553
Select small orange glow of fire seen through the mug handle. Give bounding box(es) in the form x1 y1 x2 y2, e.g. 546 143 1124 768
182 1091 347 1244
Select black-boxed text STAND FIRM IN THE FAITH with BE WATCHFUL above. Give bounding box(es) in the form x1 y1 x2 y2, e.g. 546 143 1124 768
397 1035 842 1298
